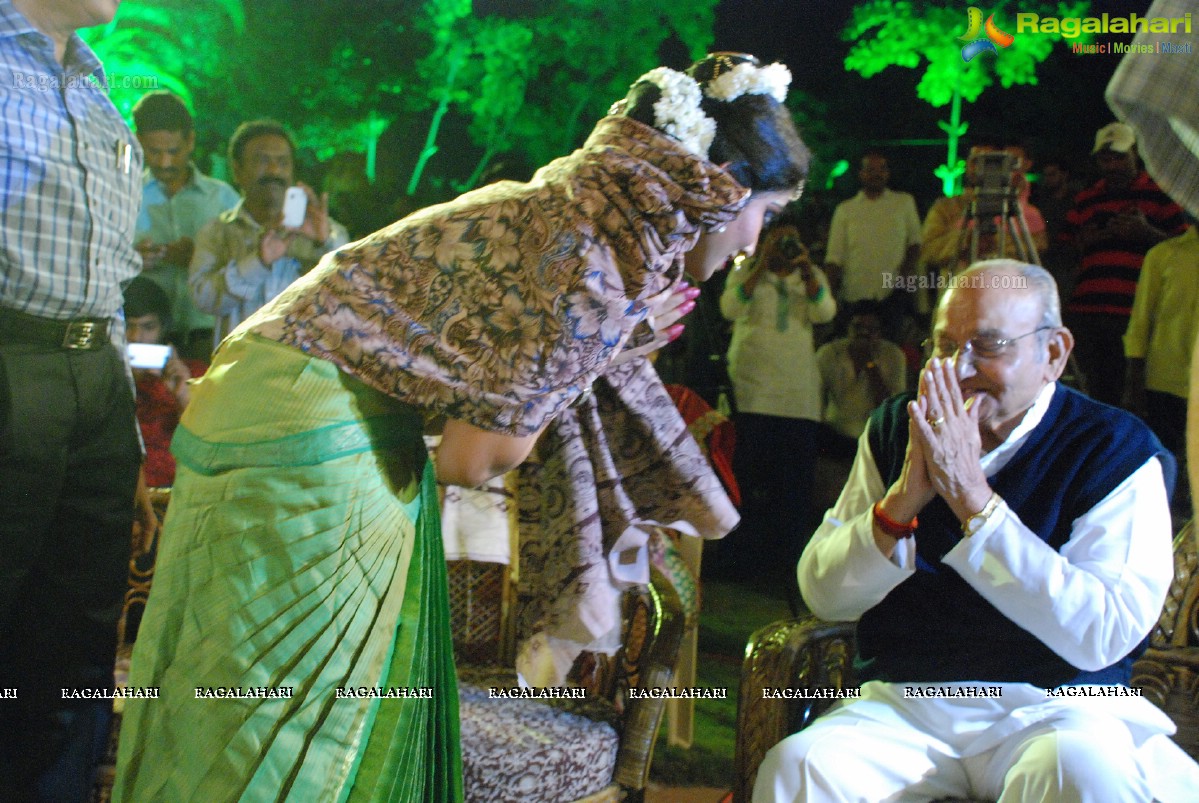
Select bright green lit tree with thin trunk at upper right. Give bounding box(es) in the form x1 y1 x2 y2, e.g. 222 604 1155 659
842 0 1090 195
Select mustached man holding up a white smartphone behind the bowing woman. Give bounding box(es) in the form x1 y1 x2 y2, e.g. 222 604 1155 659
189 120 349 349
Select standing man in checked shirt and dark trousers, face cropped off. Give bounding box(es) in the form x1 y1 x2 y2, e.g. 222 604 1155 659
0 0 153 801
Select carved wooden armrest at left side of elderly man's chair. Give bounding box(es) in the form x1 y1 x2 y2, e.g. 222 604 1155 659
733 616 856 802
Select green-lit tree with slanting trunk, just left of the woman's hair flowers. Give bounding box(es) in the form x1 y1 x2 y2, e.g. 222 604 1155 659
409 0 716 193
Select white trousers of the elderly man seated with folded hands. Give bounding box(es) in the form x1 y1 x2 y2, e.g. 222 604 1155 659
753 683 1199 803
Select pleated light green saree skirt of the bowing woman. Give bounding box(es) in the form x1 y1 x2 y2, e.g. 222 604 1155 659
114 337 462 802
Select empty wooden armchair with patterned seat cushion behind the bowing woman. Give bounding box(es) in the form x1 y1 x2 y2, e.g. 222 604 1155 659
448 561 683 803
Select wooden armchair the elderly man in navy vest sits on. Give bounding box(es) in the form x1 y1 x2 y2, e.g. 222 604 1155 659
733 523 1199 803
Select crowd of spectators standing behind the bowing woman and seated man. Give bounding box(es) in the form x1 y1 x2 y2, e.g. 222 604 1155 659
114 85 1195 613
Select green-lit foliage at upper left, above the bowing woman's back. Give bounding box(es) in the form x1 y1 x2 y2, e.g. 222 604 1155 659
85 0 717 207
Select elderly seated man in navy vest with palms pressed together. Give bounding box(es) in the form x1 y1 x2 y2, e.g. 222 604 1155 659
754 260 1199 803
